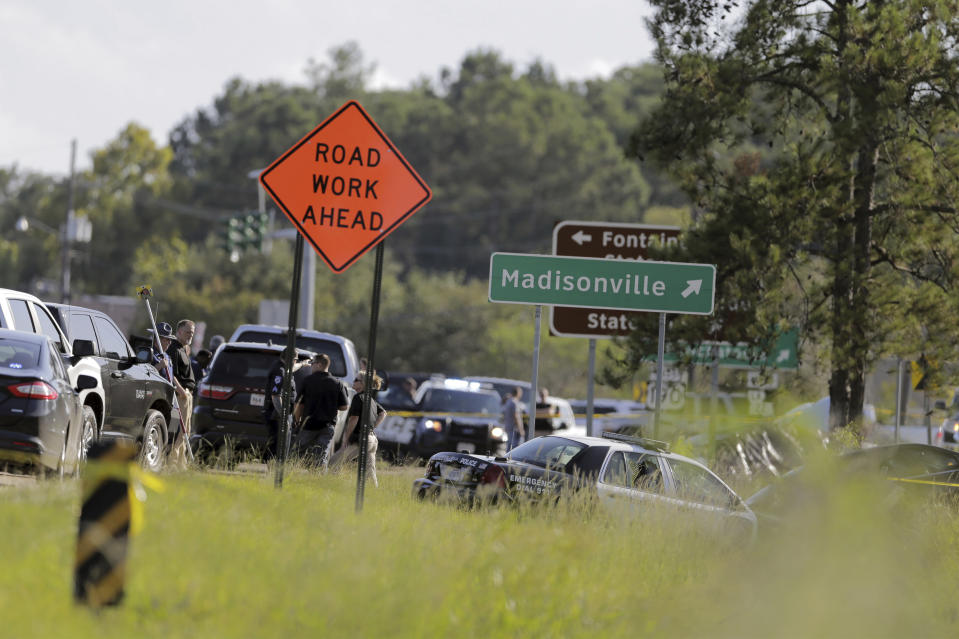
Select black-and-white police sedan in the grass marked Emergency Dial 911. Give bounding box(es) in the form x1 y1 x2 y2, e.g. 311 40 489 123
413 433 756 537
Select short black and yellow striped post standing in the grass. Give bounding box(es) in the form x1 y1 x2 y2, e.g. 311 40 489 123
73 442 136 608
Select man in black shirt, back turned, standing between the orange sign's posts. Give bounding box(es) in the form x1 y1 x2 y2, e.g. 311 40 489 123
293 353 350 468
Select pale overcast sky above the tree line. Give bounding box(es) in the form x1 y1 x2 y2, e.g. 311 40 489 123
0 0 652 174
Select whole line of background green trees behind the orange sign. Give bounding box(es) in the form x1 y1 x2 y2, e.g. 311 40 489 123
0 43 672 394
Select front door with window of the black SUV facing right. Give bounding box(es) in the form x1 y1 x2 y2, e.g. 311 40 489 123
90 313 147 437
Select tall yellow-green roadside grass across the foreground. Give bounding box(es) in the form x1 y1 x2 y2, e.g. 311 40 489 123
0 463 959 638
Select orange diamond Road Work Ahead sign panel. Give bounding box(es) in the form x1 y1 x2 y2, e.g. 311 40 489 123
260 100 433 273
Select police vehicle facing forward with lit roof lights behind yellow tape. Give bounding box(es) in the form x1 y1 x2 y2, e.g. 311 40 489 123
375 378 506 459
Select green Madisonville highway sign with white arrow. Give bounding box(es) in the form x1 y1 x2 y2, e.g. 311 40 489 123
489 253 716 315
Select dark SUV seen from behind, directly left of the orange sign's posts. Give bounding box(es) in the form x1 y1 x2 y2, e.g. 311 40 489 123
191 342 313 456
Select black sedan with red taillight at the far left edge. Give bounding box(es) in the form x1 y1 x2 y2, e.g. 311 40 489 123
0 329 97 473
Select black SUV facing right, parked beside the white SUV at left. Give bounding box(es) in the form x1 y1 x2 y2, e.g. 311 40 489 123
47 304 180 470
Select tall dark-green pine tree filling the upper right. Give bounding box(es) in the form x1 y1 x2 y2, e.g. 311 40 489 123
632 0 959 427
